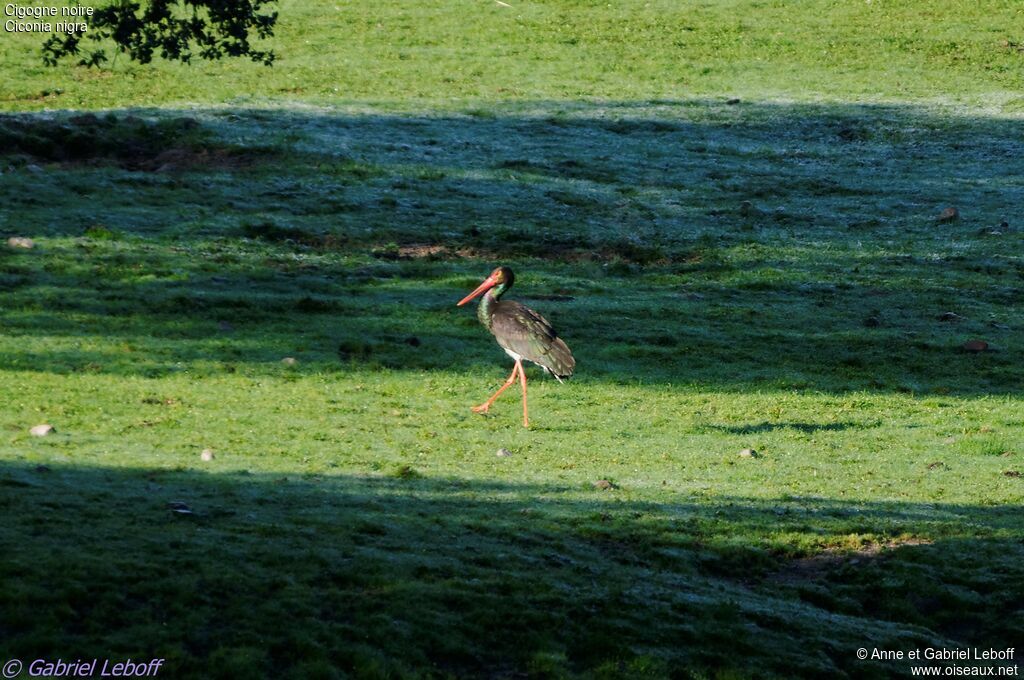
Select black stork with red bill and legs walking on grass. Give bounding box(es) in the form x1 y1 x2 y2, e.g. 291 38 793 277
459 267 575 427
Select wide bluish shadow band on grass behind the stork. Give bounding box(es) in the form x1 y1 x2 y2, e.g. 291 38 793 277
0 100 1024 395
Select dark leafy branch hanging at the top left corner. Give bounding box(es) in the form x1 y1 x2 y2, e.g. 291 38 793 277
43 0 278 67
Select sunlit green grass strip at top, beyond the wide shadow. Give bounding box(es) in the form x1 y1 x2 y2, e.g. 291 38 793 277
0 0 1024 114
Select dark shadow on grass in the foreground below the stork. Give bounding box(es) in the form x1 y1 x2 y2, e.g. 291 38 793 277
0 462 1024 677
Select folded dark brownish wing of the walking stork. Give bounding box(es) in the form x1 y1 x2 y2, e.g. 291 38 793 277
490 300 575 378
